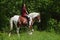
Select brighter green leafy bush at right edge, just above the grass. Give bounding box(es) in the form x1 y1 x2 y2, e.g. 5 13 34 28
47 18 60 33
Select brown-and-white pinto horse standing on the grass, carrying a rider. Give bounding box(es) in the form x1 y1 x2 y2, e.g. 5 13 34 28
9 12 40 36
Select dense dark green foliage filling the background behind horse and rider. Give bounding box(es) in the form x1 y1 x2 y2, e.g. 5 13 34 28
0 0 60 32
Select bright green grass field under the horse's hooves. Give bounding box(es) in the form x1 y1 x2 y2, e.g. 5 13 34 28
0 31 60 40
